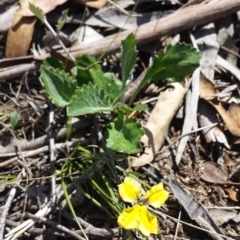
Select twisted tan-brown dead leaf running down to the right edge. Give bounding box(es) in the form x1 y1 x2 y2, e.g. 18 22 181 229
200 76 240 137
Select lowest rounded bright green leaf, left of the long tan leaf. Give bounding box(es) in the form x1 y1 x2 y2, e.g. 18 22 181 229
105 117 144 154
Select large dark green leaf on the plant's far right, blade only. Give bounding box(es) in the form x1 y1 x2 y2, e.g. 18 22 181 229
143 43 200 81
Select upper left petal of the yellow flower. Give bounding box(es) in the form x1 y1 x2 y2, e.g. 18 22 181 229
118 177 142 203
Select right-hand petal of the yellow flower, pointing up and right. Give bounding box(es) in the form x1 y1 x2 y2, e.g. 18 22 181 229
142 183 169 208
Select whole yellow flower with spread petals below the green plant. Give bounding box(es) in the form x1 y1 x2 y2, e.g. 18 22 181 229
118 177 169 236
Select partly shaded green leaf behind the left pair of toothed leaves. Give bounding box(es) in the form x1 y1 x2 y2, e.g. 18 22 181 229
71 55 122 101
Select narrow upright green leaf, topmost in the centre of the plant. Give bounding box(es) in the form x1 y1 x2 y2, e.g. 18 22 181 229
121 33 138 86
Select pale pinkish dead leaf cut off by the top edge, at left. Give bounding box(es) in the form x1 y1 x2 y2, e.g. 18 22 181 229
17 0 67 17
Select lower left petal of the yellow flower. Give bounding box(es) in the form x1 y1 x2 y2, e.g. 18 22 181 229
118 204 141 230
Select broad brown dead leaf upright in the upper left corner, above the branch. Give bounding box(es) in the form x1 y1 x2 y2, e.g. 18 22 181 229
6 14 36 58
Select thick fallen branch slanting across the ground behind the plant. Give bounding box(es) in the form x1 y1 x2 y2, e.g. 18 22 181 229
0 0 240 80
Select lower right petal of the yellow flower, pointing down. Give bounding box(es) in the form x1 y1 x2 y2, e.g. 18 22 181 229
138 205 158 236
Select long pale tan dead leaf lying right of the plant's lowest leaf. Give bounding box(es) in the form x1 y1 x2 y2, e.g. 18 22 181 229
132 83 186 167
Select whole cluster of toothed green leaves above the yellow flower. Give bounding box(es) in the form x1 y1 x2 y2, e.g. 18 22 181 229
40 34 200 154
